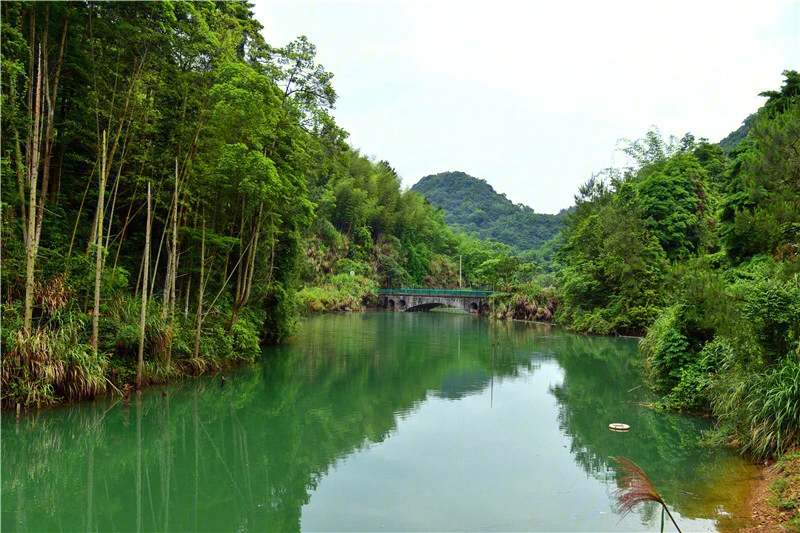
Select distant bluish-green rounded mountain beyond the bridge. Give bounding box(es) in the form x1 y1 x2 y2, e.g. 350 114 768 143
411 172 564 253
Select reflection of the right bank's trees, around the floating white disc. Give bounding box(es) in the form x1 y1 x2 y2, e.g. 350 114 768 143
551 335 752 519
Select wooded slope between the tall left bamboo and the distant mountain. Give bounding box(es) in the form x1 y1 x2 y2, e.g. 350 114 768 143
301 147 458 298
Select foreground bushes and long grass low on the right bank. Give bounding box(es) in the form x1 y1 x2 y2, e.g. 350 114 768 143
640 257 800 457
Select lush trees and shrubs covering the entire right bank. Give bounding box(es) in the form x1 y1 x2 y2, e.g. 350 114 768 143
556 71 800 457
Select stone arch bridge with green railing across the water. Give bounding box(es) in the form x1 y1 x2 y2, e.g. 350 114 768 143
378 289 493 314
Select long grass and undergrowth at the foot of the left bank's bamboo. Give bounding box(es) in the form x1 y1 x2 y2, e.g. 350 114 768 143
0 298 263 409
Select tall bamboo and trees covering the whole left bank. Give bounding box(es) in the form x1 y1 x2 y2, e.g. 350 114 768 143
2 1 476 407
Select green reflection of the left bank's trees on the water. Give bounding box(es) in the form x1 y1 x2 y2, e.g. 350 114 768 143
2 313 529 531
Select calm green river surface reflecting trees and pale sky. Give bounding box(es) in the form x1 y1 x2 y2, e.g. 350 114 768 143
0 313 752 532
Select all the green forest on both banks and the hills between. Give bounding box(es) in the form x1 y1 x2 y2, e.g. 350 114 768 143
0 1 800 464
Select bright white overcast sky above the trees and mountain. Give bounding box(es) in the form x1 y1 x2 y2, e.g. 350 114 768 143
251 0 800 213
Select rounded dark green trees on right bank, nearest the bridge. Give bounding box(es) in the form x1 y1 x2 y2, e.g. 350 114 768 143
556 175 666 334
